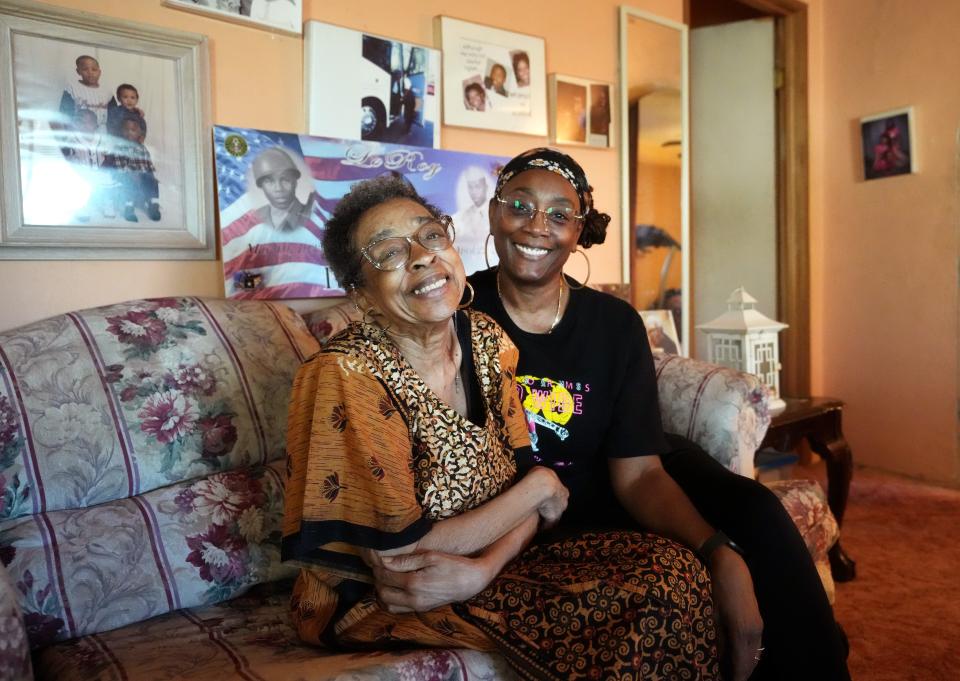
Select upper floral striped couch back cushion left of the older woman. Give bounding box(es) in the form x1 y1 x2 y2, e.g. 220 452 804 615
0 298 319 521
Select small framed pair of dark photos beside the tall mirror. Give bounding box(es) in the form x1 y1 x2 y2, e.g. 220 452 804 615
549 73 614 148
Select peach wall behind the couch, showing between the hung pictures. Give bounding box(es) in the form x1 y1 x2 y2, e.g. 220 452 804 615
0 0 683 330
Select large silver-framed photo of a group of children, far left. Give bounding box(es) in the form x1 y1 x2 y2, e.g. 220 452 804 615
0 0 216 260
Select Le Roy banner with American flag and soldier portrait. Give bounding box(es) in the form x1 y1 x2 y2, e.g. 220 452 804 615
214 126 509 298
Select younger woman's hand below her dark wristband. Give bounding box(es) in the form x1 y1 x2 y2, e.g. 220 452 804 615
710 546 763 681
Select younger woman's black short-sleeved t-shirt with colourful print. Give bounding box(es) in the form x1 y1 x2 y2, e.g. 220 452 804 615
469 269 667 522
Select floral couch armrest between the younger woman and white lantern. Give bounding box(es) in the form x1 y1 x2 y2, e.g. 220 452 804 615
654 355 770 478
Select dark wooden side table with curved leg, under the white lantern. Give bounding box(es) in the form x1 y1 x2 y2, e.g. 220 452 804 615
760 397 857 582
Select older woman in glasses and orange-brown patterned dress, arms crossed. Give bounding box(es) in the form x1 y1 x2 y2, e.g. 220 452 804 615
283 176 716 679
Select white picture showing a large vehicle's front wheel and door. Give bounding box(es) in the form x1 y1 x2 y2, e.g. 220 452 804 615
304 21 440 149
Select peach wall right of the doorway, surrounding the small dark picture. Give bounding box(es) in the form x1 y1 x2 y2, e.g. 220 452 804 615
810 0 960 484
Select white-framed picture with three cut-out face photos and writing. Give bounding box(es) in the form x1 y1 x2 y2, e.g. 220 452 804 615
434 16 547 136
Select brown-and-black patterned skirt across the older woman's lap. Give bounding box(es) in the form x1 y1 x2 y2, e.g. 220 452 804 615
294 531 720 681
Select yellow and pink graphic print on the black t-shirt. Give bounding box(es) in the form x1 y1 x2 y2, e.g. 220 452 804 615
517 375 590 466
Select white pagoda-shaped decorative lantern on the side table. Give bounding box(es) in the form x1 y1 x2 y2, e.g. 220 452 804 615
697 286 788 413
